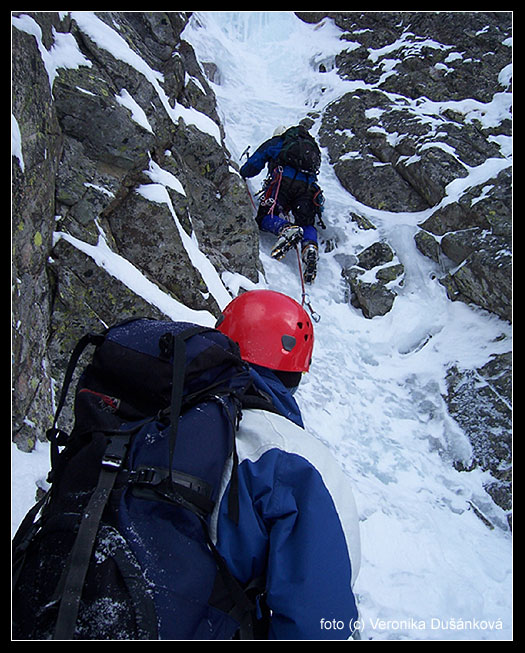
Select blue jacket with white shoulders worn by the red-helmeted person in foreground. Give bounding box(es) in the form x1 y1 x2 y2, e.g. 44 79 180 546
212 375 360 640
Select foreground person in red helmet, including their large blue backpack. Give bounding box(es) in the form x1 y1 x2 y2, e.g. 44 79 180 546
12 290 360 640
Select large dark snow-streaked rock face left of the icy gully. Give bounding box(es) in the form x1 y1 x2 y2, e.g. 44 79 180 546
12 12 262 448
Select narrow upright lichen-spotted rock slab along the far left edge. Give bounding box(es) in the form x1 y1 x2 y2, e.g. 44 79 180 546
12 19 63 442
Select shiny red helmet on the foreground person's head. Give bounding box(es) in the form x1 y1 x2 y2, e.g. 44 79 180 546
216 290 314 372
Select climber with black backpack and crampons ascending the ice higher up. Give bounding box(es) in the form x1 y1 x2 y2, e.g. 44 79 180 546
240 123 324 283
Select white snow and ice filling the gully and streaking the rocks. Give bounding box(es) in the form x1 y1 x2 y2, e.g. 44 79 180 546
12 12 512 640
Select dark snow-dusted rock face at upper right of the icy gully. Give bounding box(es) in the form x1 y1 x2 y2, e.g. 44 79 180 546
314 12 512 320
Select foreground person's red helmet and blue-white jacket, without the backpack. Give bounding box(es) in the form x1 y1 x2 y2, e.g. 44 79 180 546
217 290 360 640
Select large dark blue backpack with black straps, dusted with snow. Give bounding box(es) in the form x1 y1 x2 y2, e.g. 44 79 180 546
12 319 271 640
